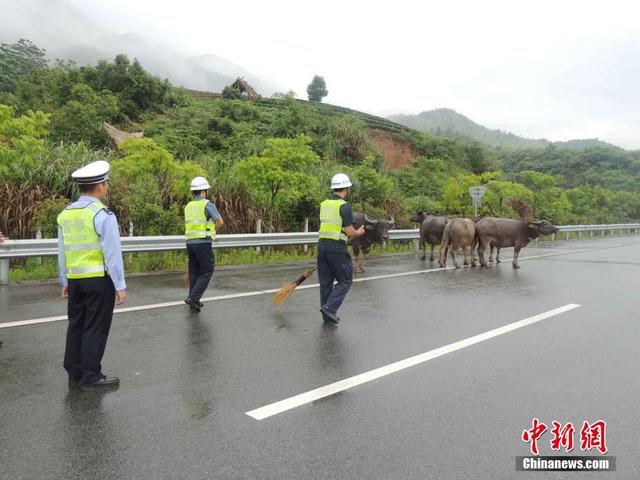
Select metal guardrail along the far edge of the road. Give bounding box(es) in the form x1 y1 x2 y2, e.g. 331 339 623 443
0 223 640 285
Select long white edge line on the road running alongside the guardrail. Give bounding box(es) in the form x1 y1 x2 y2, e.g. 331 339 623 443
0 243 638 329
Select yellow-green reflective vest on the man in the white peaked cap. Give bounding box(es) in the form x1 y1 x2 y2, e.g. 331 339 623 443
58 201 107 278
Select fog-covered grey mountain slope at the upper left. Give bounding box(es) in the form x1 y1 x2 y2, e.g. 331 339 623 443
0 0 279 96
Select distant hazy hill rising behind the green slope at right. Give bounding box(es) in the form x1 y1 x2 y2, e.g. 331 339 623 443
389 108 614 150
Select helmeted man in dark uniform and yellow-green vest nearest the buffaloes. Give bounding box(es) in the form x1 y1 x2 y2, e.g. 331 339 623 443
318 173 365 324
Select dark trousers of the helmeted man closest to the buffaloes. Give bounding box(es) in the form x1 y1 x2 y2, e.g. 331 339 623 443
318 239 353 313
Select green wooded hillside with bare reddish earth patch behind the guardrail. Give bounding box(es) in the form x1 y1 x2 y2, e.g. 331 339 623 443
0 41 640 244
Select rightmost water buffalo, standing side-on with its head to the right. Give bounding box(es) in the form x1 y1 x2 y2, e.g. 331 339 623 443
476 217 558 268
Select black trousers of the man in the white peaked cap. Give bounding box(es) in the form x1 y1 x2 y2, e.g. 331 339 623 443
64 275 116 383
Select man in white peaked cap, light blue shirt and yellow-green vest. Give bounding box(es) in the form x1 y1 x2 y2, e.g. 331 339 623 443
58 160 127 390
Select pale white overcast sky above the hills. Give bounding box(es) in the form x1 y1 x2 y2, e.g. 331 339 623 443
0 0 640 148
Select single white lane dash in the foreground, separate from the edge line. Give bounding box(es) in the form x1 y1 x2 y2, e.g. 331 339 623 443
245 303 580 420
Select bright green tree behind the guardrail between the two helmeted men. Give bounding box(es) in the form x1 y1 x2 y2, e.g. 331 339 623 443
236 135 320 230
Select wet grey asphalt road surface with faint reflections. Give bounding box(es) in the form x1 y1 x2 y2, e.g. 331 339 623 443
0 237 640 479
